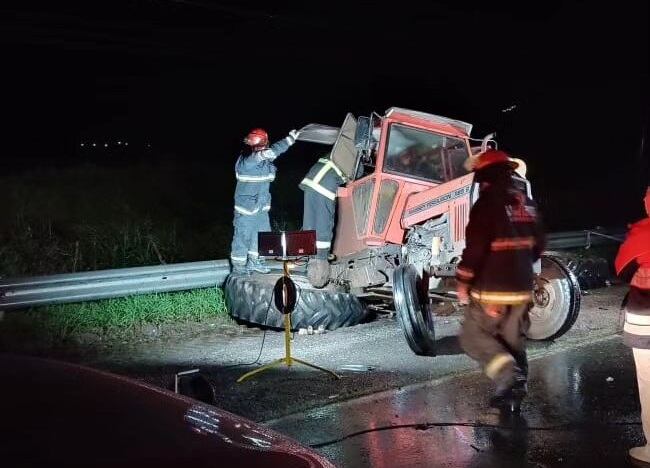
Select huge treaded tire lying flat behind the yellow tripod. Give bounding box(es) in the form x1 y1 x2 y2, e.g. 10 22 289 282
224 273 369 330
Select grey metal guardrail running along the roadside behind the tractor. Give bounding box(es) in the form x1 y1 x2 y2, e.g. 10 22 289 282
0 230 623 310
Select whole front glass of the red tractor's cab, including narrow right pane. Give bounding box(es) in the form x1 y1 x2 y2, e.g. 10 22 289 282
384 124 468 182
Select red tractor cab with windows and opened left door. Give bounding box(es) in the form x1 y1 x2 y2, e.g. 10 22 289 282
330 107 472 256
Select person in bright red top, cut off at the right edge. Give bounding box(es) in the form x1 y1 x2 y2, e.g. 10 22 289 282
614 187 650 463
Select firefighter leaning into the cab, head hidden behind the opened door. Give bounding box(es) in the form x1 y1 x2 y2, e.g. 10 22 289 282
300 157 346 288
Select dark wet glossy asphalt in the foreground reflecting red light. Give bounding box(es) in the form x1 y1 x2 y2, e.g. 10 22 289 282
269 337 643 467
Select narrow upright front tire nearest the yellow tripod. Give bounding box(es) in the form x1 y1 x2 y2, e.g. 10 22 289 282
393 265 436 356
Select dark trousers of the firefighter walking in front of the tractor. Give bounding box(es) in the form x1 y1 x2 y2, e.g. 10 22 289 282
459 300 532 390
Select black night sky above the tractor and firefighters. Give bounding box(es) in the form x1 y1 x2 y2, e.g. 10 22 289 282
0 0 648 226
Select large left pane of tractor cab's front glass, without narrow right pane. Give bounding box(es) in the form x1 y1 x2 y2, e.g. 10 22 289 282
384 124 445 182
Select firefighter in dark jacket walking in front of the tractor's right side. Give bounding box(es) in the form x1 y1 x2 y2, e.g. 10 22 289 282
456 149 545 412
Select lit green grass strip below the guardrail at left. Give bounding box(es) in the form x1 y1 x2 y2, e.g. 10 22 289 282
0 288 227 344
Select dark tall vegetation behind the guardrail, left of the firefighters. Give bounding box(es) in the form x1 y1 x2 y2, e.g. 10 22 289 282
0 164 231 277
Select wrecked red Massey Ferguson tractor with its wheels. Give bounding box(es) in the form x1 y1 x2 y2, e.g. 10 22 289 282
226 108 580 355
